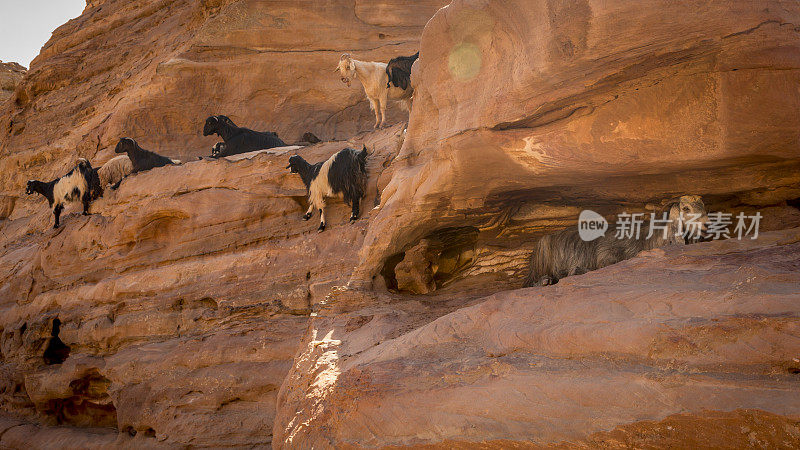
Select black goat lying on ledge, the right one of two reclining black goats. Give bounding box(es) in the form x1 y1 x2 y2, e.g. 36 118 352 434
203 115 286 158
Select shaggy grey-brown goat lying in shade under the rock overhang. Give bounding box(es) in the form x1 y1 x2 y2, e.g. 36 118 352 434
525 195 708 287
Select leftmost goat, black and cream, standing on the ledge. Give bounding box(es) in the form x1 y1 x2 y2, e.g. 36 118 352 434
25 158 102 228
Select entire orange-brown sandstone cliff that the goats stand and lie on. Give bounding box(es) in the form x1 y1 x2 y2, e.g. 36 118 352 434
0 0 800 448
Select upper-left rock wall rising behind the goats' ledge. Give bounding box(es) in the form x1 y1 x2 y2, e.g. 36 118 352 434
0 0 447 223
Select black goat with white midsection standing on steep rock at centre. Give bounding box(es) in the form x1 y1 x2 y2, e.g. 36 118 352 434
286 146 367 232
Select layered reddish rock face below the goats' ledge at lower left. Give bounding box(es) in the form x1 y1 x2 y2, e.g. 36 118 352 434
0 124 404 446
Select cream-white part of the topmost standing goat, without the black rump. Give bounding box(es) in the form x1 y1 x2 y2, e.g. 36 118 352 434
334 53 414 128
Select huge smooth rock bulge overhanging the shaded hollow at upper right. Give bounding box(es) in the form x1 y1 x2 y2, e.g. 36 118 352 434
353 0 800 285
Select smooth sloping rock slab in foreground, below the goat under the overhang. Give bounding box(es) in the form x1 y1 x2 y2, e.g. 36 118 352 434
273 228 800 448
